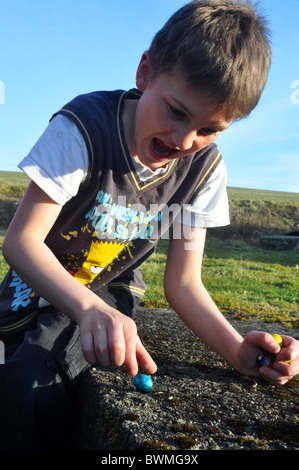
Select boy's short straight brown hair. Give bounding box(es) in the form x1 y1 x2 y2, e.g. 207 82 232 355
148 0 271 120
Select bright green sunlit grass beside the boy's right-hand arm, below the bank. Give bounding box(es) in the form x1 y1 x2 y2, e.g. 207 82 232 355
141 238 299 328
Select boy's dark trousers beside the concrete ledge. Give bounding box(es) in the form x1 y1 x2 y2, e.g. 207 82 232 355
0 287 137 450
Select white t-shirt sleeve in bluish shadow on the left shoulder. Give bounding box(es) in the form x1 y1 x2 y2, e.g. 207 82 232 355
18 115 88 205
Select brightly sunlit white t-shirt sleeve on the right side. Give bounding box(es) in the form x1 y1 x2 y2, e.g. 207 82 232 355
175 160 230 228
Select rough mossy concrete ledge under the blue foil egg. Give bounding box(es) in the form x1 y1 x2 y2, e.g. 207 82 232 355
72 309 299 451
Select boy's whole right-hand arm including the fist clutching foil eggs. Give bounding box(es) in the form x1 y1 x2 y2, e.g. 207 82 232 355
164 226 299 383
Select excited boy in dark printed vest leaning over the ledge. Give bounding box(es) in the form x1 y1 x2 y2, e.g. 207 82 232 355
0 0 299 449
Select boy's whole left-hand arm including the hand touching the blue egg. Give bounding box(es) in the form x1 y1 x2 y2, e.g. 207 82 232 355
2 182 156 375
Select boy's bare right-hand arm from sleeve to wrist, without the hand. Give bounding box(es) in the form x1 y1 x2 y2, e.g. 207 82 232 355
164 226 243 368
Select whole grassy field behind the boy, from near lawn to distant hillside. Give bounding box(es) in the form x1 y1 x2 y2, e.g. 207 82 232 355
0 172 299 328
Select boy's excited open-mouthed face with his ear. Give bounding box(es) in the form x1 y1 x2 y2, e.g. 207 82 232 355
127 53 230 170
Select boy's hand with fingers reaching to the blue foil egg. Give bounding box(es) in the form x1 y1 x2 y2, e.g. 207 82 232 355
80 308 157 376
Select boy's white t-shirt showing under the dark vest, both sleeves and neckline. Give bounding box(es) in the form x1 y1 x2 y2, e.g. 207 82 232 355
19 115 229 227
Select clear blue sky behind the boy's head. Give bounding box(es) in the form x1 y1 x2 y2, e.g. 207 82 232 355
0 0 299 192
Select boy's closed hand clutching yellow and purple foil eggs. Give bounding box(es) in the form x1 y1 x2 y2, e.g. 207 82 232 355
239 331 299 385
